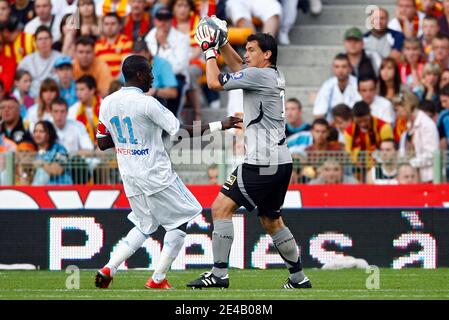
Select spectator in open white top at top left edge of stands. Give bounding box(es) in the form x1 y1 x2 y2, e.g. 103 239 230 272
25 0 61 41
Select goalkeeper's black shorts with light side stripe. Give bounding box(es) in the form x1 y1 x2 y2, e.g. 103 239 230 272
221 163 293 219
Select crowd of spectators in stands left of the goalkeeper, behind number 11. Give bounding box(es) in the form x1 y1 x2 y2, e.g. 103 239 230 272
0 0 322 185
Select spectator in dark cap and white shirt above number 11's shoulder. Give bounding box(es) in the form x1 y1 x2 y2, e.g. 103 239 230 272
145 6 191 116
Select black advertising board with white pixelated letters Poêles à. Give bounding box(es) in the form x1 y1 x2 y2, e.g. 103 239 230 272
0 208 449 270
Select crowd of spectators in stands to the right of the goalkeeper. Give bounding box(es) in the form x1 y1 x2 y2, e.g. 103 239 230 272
286 0 449 184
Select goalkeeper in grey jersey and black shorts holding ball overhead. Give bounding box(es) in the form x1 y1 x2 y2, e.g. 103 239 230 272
187 16 312 289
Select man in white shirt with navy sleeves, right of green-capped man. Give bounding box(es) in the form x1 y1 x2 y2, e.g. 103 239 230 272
363 8 405 60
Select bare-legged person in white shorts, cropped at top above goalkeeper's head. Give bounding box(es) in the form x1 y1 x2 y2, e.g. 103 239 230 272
226 0 282 37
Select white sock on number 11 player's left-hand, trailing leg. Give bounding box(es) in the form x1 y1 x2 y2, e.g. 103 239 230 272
106 227 147 277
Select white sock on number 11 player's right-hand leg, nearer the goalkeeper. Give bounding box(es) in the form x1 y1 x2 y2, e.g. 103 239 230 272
151 229 186 283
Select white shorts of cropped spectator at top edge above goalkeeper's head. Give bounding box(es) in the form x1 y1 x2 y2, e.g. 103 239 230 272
226 0 282 25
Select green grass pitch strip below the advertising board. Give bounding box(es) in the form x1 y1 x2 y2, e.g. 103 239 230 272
0 268 449 300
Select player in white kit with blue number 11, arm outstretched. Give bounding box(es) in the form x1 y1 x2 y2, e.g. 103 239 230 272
95 55 242 289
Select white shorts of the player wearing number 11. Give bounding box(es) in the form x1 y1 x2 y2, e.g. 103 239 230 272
128 177 203 235
